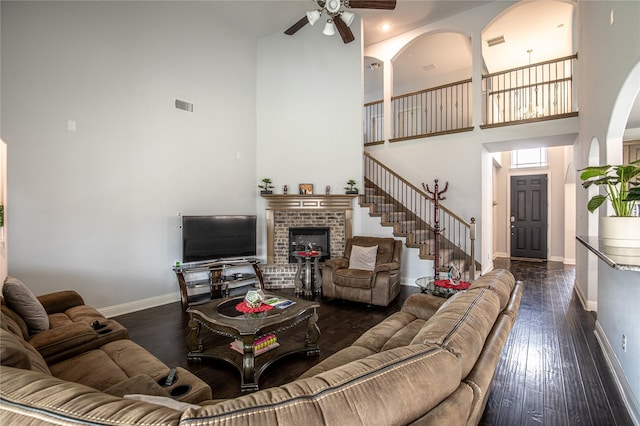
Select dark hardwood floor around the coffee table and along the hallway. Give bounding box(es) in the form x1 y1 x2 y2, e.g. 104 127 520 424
114 260 633 426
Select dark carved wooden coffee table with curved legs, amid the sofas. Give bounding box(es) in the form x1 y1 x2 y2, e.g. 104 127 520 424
187 294 320 391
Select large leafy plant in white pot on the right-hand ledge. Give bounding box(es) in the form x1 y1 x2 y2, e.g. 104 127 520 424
580 160 640 254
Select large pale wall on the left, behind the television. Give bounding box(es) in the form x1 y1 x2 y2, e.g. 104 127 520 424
2 2 257 307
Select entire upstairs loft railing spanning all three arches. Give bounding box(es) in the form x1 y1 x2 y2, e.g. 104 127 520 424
364 54 578 145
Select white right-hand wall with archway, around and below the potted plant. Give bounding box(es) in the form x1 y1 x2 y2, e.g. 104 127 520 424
576 1 640 422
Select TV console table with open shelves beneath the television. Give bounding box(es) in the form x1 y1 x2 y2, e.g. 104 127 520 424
173 258 264 311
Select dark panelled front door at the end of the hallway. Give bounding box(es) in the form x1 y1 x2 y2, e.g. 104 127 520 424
510 175 547 259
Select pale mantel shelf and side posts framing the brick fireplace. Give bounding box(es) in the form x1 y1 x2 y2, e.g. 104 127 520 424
261 194 357 264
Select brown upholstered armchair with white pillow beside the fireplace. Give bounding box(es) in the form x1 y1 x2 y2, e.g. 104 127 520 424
322 236 402 306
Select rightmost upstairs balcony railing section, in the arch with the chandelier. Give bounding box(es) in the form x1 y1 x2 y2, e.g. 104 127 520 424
481 55 578 128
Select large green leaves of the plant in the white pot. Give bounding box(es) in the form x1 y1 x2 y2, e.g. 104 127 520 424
580 160 640 216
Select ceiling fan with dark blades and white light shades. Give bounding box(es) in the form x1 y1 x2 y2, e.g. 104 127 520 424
284 0 396 43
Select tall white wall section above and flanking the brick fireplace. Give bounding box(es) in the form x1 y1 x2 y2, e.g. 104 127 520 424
256 19 363 249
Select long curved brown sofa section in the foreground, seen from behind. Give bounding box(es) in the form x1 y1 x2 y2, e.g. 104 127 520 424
0 270 523 425
